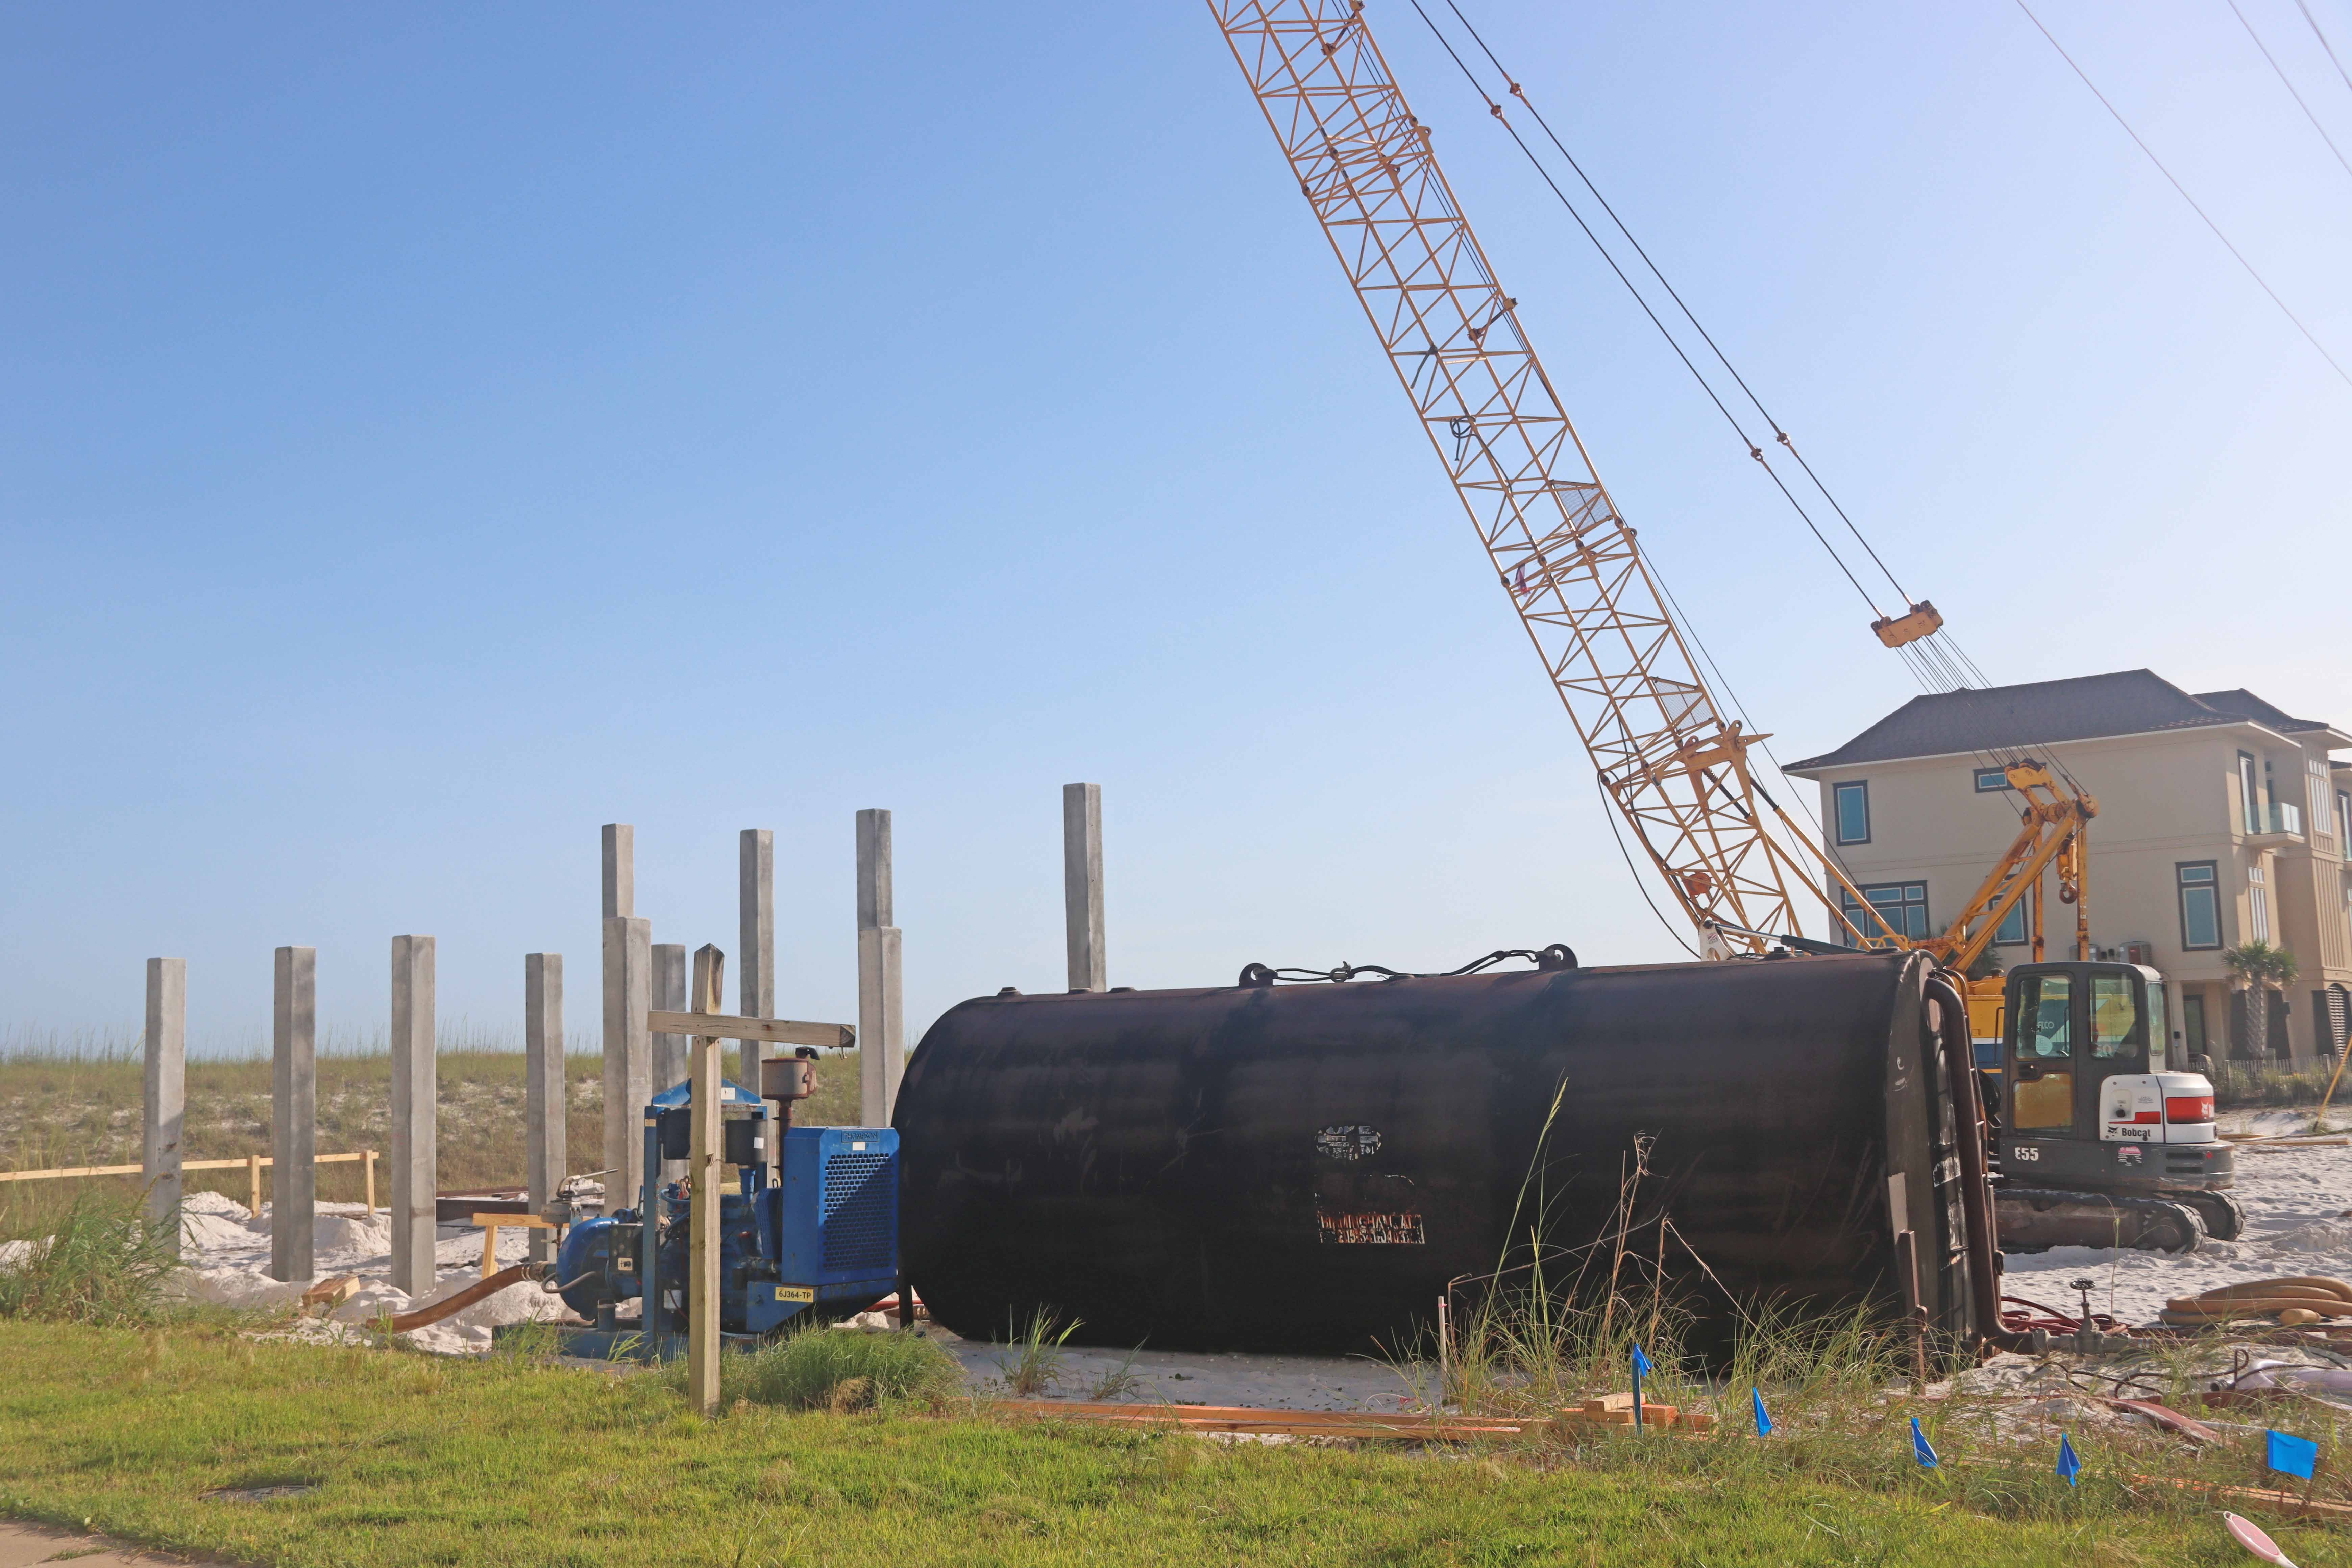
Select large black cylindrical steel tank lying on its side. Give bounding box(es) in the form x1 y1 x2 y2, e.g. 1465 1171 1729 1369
891 954 1973 1352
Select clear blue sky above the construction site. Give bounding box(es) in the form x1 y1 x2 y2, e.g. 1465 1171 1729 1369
0 0 2352 1049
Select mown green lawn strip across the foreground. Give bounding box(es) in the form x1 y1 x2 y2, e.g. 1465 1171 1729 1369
0 1321 2352 1568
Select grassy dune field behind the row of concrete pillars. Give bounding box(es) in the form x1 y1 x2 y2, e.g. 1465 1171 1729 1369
0 1030 858 1225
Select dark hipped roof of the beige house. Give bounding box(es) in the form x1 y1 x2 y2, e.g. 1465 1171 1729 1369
1783 670 2328 774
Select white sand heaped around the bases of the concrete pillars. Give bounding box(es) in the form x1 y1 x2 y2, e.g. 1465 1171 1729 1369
162 1192 571 1354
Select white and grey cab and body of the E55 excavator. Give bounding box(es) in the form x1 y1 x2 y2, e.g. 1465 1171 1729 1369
1994 961 2244 1251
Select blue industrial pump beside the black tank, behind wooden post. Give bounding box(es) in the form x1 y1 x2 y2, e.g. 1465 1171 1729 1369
555 1053 899 1356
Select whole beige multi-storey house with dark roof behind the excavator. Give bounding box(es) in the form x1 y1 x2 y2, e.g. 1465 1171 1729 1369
1788 670 2352 1060
